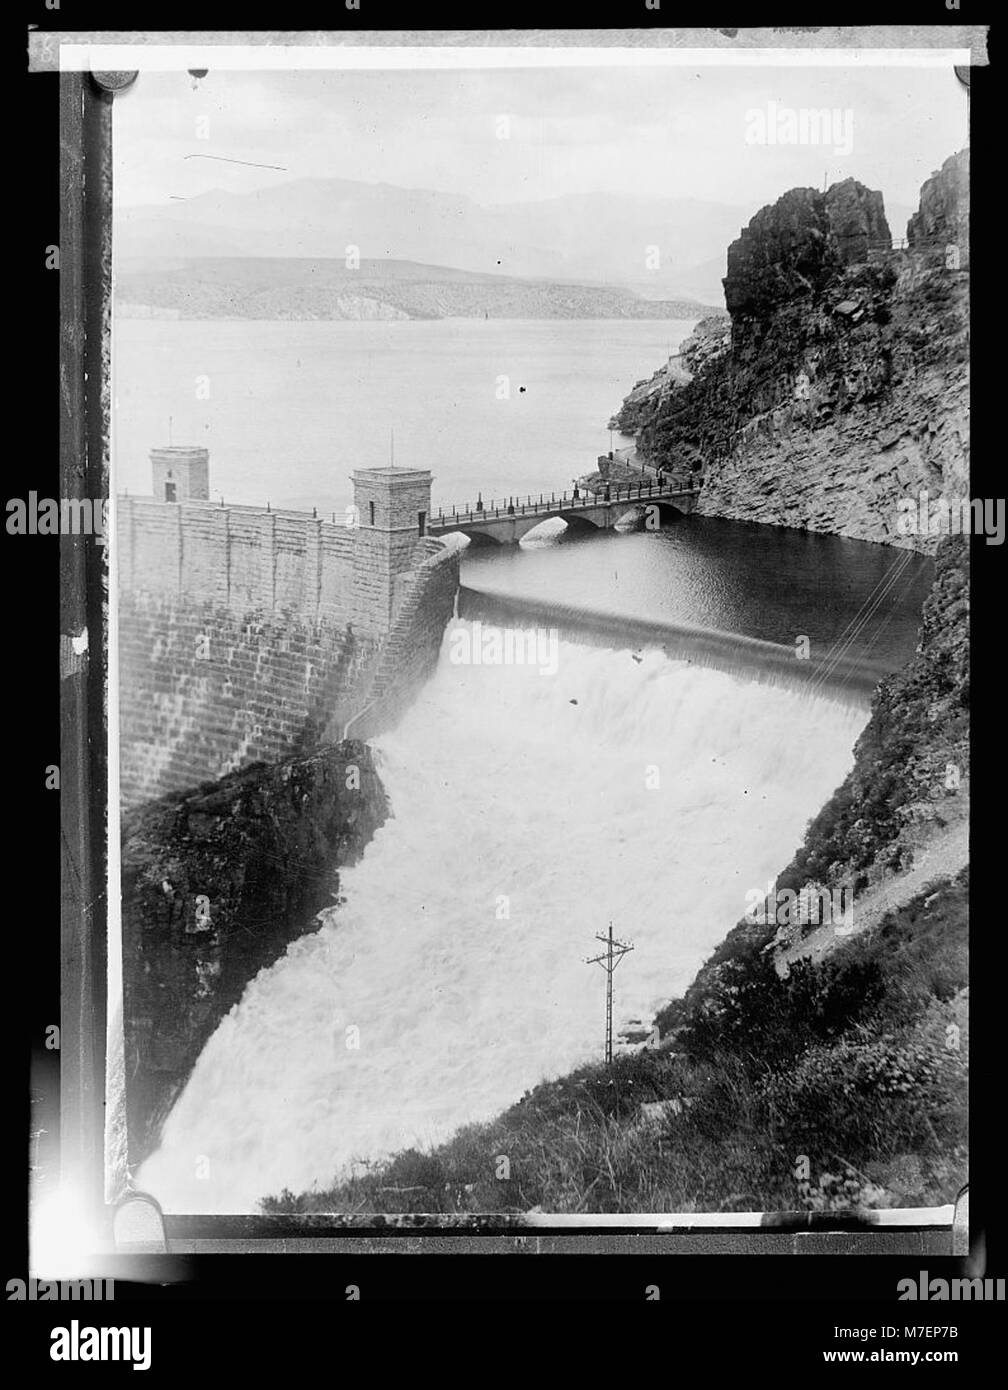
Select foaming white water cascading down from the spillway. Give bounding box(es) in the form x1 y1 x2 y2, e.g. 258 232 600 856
138 620 868 1212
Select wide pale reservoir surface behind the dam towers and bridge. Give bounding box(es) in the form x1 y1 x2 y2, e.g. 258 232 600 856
114 318 694 513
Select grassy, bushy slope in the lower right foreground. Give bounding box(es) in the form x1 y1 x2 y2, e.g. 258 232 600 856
263 872 968 1213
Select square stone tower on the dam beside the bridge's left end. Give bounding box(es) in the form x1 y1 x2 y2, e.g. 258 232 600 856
353 467 432 635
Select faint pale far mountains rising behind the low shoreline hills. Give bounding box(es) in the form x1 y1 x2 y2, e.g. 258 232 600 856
115 179 755 309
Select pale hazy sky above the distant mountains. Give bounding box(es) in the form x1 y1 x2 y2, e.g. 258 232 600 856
114 65 966 209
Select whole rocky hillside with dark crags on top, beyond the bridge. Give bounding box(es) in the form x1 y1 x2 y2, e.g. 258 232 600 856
616 152 969 550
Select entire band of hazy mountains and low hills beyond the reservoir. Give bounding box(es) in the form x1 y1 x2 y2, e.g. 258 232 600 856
115 178 911 318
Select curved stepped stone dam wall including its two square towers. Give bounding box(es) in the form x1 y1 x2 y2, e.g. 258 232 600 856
115 446 459 808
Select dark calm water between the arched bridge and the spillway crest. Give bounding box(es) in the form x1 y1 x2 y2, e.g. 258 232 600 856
462 516 933 695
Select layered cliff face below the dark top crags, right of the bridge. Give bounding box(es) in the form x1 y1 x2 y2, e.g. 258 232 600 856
698 265 969 552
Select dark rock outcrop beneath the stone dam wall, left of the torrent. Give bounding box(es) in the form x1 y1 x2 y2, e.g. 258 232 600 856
122 742 388 1163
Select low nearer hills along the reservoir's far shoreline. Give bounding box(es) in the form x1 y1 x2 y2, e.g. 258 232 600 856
115 256 706 320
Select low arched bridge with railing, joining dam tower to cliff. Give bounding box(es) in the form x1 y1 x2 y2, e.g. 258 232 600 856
427 478 699 545
